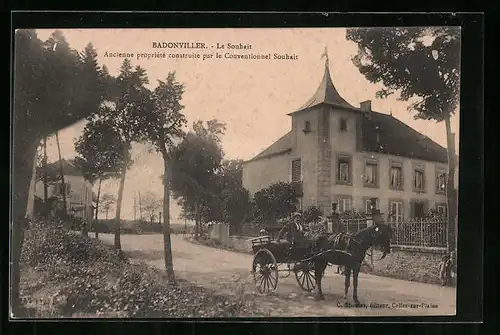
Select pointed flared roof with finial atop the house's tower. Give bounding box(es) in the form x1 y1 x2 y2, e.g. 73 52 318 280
291 47 358 114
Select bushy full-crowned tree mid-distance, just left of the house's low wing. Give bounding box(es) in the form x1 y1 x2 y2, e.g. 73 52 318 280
172 120 225 238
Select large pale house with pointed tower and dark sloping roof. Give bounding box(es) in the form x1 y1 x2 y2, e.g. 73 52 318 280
243 56 454 221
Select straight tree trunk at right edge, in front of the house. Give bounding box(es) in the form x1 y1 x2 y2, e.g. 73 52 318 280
444 117 458 252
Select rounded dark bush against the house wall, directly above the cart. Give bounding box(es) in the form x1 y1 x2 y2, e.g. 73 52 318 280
253 181 298 223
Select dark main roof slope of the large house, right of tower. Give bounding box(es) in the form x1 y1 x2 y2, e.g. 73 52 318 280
362 111 448 163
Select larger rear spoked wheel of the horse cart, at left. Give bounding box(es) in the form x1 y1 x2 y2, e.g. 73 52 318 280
252 249 278 294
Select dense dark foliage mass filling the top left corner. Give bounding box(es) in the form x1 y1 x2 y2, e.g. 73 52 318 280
14 30 105 138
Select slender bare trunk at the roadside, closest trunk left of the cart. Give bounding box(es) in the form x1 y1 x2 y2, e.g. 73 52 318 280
163 159 175 284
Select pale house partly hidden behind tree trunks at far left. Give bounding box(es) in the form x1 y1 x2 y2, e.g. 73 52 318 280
34 159 94 222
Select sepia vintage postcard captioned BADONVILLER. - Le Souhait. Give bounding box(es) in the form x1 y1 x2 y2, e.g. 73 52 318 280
10 27 461 319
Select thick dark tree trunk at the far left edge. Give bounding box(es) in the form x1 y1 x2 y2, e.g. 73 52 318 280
10 132 40 317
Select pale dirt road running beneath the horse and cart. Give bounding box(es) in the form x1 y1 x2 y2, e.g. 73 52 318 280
100 234 456 316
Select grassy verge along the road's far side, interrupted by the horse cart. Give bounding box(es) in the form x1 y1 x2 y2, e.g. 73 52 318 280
185 237 454 285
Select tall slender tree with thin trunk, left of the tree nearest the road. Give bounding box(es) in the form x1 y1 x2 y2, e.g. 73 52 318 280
88 58 151 252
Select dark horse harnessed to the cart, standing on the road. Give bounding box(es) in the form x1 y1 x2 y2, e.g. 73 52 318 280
312 223 392 305
